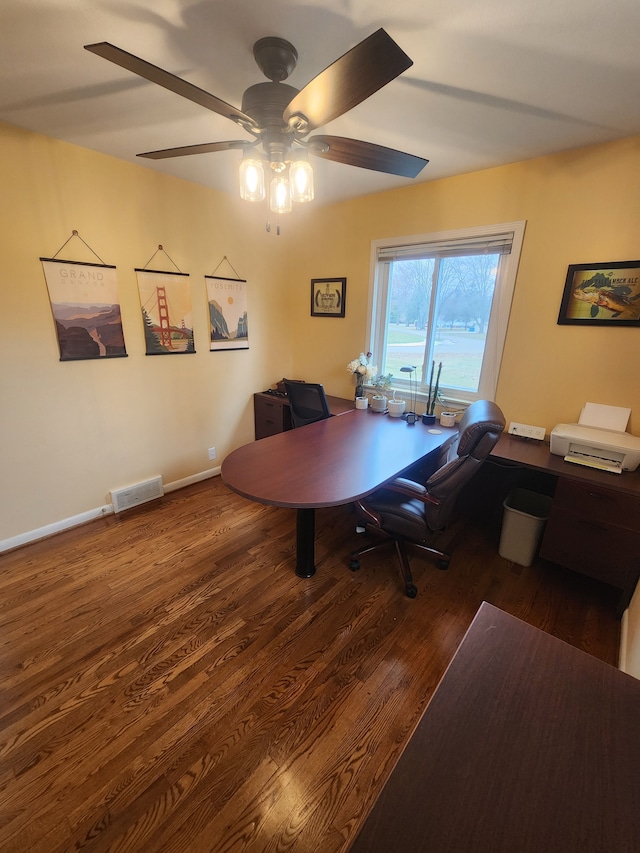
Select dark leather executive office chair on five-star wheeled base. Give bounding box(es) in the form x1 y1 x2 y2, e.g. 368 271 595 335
349 400 505 598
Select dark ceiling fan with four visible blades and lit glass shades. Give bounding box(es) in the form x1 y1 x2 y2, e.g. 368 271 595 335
85 29 429 213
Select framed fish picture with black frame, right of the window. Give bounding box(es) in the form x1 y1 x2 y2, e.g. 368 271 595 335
558 261 640 326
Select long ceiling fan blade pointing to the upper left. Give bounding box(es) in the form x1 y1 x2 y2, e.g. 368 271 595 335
84 41 256 129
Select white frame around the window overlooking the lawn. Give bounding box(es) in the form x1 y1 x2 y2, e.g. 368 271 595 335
367 220 526 406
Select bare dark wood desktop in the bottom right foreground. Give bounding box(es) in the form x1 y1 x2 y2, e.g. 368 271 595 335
350 603 640 853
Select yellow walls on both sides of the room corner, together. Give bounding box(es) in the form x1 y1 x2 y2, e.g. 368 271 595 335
0 118 640 542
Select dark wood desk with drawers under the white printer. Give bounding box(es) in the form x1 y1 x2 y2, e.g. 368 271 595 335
491 435 640 616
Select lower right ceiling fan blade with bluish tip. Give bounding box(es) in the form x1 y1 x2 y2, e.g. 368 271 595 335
308 135 429 178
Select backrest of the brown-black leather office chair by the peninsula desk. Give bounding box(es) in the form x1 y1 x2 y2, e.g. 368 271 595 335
426 400 505 530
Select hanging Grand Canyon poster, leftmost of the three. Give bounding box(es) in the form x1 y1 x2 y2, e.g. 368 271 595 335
40 258 127 361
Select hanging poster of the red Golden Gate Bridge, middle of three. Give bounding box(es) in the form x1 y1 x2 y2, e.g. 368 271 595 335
136 270 195 355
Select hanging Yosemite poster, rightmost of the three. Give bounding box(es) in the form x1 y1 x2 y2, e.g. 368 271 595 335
205 275 249 351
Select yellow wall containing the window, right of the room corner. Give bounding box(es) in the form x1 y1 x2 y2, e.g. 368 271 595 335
291 137 640 434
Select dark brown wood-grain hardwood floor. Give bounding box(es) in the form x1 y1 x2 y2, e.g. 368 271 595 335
0 478 619 853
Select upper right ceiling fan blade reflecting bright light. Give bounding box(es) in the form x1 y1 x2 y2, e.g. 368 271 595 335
284 29 413 132
